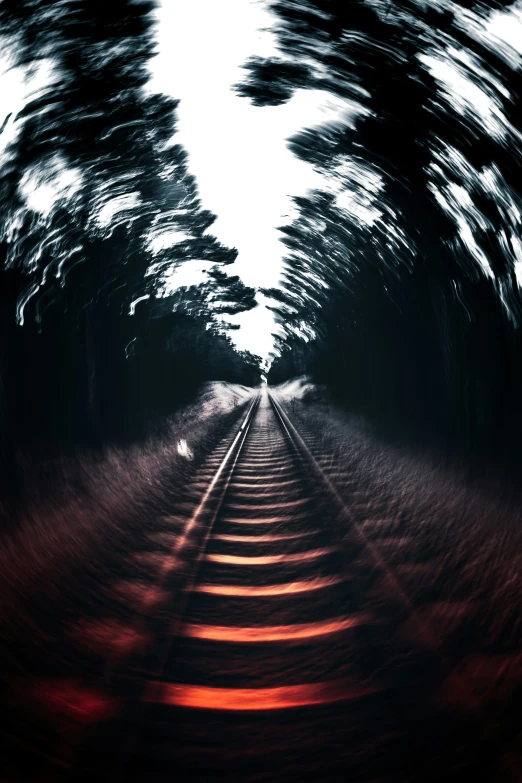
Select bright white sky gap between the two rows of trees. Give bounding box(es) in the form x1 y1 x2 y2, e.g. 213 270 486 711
147 0 348 357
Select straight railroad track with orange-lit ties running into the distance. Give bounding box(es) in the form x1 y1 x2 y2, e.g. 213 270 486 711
4 390 496 783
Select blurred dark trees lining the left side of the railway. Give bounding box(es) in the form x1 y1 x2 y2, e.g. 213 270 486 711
0 0 259 500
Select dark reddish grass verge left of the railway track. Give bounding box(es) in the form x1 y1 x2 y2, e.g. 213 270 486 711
0 384 251 635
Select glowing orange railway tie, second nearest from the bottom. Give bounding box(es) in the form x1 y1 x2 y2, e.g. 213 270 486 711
183 614 373 644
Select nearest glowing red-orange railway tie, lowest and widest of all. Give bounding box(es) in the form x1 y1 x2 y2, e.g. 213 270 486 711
145 680 378 711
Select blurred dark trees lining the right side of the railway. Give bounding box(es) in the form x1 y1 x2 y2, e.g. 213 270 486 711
242 0 522 466
